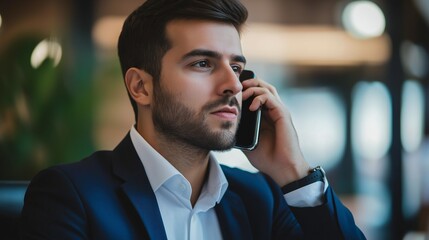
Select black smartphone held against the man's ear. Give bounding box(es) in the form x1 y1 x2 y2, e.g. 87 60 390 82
234 70 261 151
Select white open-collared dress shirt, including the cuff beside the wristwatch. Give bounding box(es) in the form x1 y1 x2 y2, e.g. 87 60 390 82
130 126 327 240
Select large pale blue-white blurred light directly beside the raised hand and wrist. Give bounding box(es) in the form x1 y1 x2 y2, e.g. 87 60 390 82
281 88 346 170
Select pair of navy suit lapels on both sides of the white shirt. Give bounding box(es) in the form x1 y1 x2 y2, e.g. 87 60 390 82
112 134 252 240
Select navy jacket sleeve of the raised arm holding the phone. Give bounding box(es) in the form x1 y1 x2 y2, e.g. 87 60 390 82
265 172 366 240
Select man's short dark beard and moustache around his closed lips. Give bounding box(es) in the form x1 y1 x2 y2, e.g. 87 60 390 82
152 86 241 151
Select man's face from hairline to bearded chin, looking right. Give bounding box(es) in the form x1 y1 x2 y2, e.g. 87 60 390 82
152 20 245 150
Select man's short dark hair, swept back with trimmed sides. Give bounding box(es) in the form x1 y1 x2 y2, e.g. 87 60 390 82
118 0 248 122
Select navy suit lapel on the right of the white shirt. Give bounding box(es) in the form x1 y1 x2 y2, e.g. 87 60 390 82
216 190 252 240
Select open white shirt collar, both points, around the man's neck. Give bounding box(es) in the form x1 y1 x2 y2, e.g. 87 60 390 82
130 126 228 203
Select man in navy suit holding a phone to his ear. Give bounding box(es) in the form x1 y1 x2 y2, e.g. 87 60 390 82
22 0 364 239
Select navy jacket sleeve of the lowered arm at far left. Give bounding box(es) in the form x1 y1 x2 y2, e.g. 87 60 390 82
21 168 88 239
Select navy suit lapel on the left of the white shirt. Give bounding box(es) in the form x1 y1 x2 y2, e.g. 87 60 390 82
112 134 167 239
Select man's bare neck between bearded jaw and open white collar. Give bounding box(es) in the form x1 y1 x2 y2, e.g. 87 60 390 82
137 124 209 206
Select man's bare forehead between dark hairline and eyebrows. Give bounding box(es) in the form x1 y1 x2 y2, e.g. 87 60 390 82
166 20 242 55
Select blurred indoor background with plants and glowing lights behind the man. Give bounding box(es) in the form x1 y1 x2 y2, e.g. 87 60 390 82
0 0 429 240
